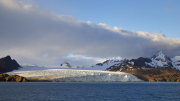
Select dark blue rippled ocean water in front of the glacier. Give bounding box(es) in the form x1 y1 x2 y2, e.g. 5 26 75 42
0 82 180 101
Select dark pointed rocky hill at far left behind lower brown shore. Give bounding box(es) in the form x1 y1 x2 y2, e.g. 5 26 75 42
0 56 21 73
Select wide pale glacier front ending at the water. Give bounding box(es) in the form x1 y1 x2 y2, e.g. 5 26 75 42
7 67 141 82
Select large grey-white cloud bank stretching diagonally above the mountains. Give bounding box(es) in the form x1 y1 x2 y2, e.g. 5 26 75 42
0 0 180 65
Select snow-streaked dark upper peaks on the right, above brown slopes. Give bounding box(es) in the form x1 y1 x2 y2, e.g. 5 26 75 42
93 51 180 70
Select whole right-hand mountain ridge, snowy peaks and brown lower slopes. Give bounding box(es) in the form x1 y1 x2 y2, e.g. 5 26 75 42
102 51 180 82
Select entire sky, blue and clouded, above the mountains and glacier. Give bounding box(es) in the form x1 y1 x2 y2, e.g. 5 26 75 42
0 0 180 66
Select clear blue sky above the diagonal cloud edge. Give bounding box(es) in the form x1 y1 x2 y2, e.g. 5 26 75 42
24 0 180 38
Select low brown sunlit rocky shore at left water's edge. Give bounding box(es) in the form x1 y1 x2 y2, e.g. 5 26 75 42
0 73 28 82
